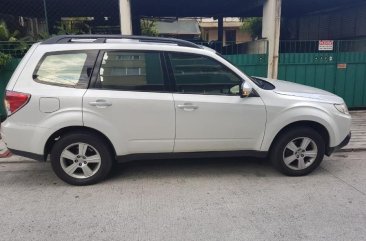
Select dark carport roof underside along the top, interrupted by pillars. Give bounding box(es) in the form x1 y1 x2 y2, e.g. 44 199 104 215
0 0 365 19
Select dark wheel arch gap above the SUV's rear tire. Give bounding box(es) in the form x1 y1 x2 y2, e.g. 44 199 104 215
43 126 116 160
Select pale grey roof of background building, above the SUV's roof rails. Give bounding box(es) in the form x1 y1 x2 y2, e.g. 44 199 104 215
156 19 201 35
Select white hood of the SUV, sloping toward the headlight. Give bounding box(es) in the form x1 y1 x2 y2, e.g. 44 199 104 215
261 78 344 103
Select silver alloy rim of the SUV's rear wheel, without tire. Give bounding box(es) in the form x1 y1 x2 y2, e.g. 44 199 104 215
60 142 101 179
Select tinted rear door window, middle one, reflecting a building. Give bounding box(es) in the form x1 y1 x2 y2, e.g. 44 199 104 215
97 51 165 91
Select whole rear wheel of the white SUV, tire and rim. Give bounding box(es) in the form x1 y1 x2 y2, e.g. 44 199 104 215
51 132 113 185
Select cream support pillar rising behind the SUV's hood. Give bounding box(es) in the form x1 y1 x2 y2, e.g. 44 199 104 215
262 0 282 79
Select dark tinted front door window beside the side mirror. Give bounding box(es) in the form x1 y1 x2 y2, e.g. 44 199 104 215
169 53 241 95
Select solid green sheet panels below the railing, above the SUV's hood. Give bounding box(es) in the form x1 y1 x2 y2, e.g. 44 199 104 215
278 52 366 107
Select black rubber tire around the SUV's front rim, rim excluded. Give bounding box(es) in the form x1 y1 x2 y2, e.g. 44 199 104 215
270 127 325 176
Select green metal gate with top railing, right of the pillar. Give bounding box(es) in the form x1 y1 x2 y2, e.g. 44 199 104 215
278 40 366 107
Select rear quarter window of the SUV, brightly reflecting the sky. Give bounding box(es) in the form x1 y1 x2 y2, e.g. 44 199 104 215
33 51 97 88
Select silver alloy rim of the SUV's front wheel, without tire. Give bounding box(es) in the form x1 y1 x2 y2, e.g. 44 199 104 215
283 137 318 171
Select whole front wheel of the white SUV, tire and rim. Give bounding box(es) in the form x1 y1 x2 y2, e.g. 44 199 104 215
271 127 325 176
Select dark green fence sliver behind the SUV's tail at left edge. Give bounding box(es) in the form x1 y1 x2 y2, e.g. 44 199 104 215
0 58 21 117
